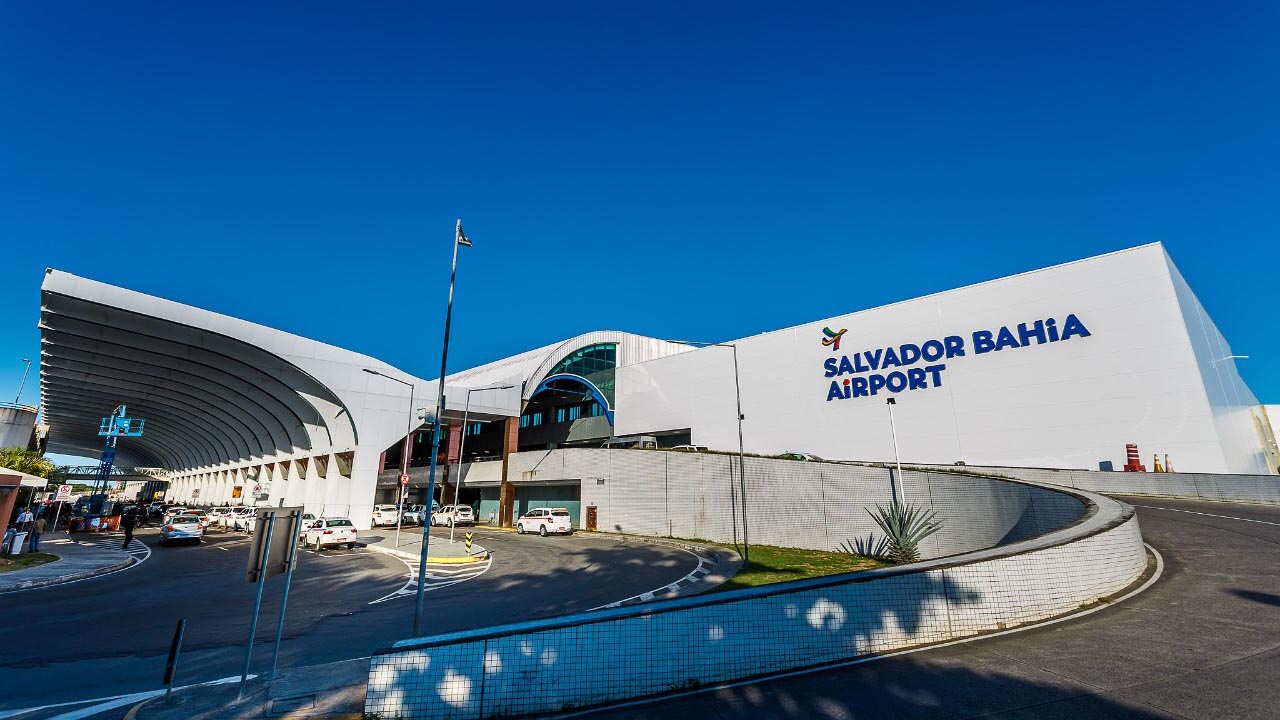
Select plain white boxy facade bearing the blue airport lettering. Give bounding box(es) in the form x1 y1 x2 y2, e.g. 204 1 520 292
616 243 1275 473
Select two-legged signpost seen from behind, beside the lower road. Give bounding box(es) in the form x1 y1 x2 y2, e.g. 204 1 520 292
237 507 302 698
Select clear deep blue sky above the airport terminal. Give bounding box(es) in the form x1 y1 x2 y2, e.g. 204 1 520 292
0 1 1280 461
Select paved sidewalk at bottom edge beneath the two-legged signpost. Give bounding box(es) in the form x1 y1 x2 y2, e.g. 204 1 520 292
128 659 369 720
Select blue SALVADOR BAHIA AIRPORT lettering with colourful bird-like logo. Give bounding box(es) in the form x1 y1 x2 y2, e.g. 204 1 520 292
822 315 1092 402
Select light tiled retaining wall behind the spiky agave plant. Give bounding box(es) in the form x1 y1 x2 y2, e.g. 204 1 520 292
512 448 1084 557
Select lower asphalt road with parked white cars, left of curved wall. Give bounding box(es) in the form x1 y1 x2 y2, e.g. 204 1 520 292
0 520 698 720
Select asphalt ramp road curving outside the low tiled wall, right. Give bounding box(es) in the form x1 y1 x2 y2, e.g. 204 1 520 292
585 497 1280 720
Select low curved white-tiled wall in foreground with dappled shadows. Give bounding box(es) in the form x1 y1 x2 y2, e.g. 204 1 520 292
365 481 1146 719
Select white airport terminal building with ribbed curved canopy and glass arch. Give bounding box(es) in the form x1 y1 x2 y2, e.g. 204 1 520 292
40 243 1280 527
